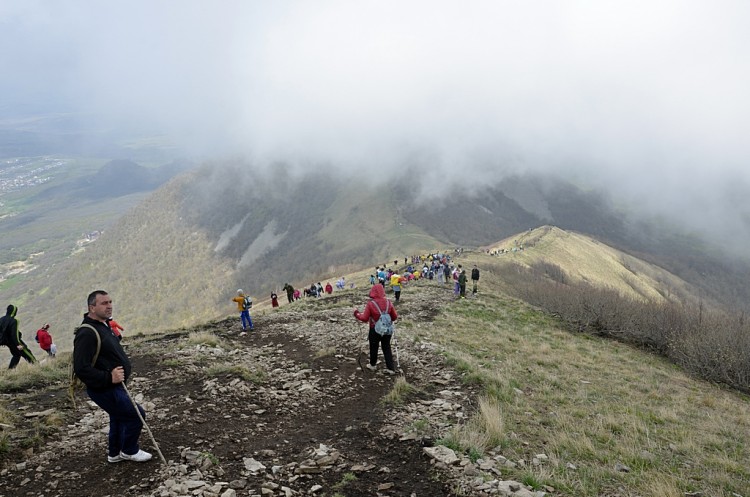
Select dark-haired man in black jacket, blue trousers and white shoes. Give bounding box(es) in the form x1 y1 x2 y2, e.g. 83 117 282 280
73 290 151 463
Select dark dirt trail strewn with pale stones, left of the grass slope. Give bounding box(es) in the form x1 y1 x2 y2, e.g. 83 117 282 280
0 285 473 497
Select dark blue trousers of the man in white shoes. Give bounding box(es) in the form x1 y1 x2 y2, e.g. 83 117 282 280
86 385 146 457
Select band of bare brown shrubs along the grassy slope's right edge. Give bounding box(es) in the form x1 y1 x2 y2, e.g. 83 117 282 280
503 265 750 392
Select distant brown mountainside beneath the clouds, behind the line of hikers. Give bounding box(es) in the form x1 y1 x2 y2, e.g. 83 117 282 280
0 161 747 354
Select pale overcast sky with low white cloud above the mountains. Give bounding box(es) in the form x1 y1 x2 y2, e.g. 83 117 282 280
0 0 750 243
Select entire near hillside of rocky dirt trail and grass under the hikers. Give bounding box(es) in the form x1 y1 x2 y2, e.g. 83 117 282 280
0 258 750 497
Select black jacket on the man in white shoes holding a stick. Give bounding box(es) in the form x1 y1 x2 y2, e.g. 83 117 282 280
73 314 132 391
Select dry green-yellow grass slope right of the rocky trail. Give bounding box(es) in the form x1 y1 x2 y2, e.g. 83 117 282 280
420 260 750 497
